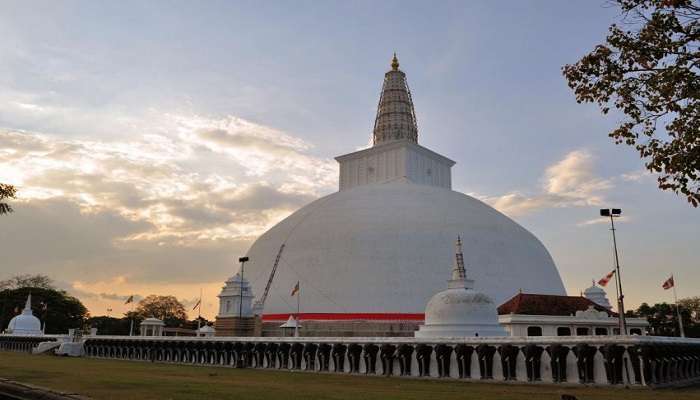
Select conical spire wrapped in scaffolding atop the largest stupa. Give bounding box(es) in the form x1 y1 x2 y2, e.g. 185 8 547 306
373 53 418 146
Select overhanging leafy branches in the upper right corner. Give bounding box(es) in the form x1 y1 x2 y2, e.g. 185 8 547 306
562 0 700 207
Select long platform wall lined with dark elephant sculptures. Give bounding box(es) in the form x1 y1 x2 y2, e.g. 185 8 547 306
0 335 700 388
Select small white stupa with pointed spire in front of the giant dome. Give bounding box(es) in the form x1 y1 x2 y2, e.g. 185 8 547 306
415 237 506 338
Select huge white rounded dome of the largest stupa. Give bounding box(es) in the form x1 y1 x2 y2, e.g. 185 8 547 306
246 182 565 314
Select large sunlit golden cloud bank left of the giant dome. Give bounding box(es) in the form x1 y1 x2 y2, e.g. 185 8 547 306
0 115 337 318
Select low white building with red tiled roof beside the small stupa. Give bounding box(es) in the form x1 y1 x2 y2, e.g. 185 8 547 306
498 293 649 336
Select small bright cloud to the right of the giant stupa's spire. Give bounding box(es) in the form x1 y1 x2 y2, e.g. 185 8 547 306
479 150 613 216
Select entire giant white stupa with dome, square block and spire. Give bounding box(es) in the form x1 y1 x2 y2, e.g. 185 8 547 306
246 57 565 321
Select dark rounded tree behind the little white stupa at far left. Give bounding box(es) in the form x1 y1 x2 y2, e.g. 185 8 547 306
0 287 88 334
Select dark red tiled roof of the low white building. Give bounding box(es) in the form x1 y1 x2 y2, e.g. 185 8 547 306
498 293 617 317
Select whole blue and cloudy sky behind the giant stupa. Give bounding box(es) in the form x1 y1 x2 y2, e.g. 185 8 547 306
0 0 700 316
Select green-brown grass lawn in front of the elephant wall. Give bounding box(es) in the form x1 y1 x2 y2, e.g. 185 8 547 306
0 352 700 400
